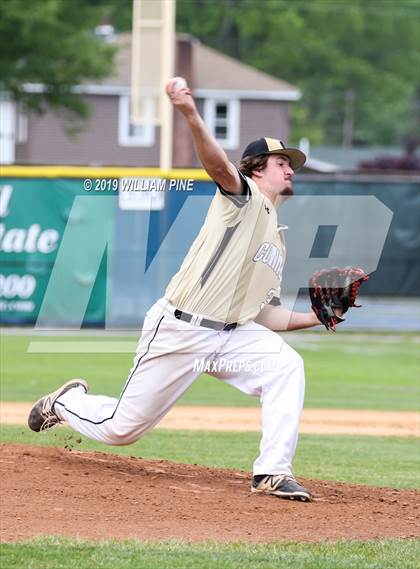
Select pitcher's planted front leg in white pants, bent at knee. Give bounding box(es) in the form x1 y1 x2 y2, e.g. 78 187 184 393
213 323 305 475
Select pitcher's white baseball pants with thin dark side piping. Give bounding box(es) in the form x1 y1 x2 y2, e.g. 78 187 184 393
55 298 305 474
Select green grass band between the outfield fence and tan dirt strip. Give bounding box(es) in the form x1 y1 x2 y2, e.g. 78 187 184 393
0 331 420 410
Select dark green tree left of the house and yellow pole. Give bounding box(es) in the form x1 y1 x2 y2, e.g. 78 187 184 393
0 0 115 116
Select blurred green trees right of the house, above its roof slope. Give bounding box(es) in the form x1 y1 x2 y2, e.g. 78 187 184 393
177 0 420 144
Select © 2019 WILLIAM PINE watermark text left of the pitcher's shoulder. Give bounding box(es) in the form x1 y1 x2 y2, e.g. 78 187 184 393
83 178 194 192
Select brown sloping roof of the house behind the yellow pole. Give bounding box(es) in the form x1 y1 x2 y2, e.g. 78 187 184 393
101 33 300 101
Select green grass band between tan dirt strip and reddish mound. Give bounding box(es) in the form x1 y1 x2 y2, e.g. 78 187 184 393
0 426 420 488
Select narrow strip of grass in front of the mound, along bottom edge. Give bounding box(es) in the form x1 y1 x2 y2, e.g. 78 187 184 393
0 537 420 569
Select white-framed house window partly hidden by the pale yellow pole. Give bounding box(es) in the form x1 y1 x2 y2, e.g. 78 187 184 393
118 95 155 146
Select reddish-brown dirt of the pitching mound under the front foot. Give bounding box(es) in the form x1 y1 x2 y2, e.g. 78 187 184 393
0 444 420 542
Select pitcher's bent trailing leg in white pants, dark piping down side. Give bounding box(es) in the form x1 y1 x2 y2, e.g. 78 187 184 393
31 308 217 445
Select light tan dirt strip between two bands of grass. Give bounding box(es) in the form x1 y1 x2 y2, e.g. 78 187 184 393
0 402 420 437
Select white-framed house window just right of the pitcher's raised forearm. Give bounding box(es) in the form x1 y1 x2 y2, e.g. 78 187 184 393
204 99 239 150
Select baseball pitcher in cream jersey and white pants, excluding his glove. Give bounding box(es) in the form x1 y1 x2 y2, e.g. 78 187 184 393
28 75 360 501
